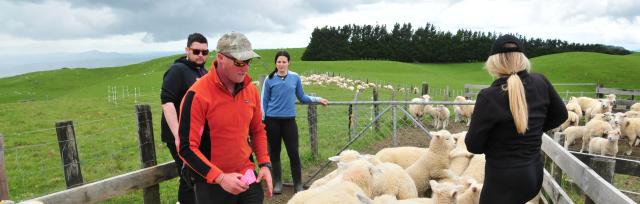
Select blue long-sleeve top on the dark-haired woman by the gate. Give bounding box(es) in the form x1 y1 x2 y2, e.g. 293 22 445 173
260 71 321 119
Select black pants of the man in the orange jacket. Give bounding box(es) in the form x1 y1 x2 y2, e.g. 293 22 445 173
195 182 264 204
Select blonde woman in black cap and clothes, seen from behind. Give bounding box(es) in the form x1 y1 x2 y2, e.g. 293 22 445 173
465 35 567 204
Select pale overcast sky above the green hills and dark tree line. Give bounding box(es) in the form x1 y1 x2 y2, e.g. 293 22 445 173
0 0 640 55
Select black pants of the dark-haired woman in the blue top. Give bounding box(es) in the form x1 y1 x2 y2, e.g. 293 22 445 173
265 117 302 184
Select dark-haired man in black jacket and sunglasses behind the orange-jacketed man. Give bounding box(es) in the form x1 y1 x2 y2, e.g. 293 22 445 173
160 33 209 204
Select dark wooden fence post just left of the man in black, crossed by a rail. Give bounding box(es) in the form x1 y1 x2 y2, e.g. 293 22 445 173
136 104 160 203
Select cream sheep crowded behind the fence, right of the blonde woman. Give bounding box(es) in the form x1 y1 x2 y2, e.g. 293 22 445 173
554 95 640 157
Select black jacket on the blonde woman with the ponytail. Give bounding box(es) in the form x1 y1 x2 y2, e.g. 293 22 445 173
465 71 567 168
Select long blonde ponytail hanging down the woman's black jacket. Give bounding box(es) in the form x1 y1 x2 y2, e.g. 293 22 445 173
507 74 529 134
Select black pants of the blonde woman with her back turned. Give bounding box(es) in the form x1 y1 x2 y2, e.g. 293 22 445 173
480 160 543 204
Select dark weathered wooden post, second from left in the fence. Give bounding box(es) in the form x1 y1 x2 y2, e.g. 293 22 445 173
56 120 84 188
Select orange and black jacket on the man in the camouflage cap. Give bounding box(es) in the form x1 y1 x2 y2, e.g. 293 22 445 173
177 61 270 184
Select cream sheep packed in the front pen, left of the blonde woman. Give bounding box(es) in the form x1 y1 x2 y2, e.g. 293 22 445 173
288 130 539 204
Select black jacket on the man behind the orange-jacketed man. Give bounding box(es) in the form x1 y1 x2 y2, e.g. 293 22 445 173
160 57 207 142
